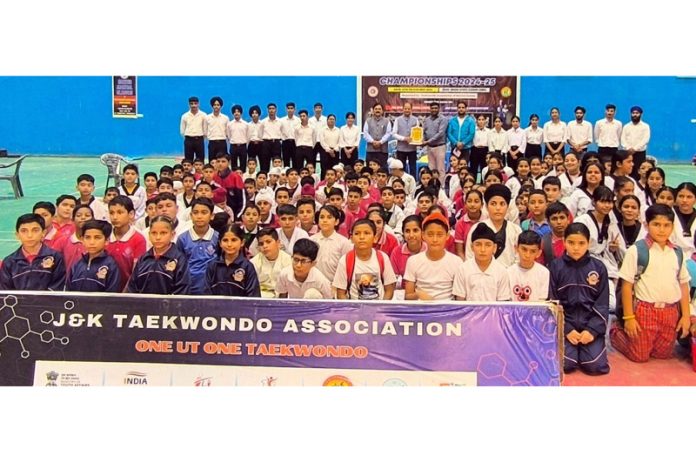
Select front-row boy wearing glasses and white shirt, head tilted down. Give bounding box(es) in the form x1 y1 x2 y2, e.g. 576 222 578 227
276 239 333 299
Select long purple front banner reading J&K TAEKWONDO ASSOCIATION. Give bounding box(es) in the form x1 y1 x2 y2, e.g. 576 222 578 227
0 292 563 386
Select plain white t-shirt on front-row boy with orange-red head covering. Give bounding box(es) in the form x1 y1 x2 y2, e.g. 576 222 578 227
404 252 462 300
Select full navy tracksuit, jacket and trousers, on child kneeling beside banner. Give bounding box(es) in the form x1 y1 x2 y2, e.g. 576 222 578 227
549 253 609 374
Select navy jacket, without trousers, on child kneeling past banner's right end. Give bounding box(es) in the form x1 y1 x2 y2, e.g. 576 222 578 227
549 252 609 338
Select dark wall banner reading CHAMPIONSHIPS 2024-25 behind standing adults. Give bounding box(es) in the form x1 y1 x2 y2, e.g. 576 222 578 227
362 75 518 128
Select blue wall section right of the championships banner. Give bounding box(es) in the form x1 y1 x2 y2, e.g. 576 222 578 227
520 77 696 162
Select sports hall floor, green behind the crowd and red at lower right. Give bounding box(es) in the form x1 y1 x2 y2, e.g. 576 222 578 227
0 156 696 386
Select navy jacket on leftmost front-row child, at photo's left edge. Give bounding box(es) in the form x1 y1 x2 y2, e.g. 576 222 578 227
0 244 65 291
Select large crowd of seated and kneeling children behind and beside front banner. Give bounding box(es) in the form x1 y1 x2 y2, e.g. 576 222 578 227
0 143 696 374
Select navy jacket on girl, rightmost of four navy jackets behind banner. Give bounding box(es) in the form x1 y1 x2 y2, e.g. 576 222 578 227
204 255 261 297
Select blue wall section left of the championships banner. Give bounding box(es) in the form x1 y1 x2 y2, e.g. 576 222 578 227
0 76 357 156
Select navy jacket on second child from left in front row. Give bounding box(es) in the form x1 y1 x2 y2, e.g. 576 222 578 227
65 252 121 292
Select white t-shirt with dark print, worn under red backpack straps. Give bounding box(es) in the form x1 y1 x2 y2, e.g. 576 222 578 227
333 250 396 300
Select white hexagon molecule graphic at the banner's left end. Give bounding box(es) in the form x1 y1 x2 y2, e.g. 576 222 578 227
0 295 69 359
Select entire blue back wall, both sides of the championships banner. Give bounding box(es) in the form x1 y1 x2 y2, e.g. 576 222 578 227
0 76 696 162
